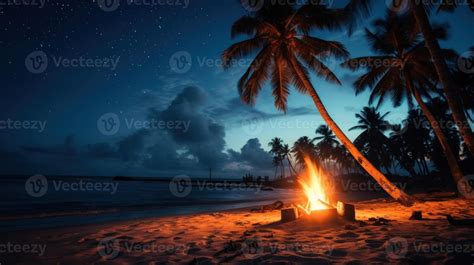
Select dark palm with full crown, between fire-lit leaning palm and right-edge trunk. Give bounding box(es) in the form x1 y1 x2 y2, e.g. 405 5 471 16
343 12 463 190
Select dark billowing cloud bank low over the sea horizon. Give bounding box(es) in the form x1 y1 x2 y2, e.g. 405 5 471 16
18 87 276 175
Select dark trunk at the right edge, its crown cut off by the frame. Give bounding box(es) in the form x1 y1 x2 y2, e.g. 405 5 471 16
410 0 474 155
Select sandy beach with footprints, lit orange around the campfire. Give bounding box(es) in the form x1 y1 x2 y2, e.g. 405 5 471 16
0 194 474 264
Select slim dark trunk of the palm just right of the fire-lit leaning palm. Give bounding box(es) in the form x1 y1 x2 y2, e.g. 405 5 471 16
411 86 464 186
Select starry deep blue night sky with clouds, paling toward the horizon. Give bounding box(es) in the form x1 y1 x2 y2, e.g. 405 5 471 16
0 0 474 177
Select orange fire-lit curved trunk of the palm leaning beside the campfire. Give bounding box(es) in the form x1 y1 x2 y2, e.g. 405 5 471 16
302 84 415 206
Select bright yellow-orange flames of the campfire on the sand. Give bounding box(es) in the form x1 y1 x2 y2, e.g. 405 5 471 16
298 157 331 214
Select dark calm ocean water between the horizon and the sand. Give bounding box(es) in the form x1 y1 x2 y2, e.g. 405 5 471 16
0 176 296 232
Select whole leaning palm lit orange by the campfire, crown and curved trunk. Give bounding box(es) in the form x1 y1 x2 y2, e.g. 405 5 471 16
222 2 414 205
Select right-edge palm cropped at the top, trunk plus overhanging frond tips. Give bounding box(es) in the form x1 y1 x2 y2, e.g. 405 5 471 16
339 0 474 155
